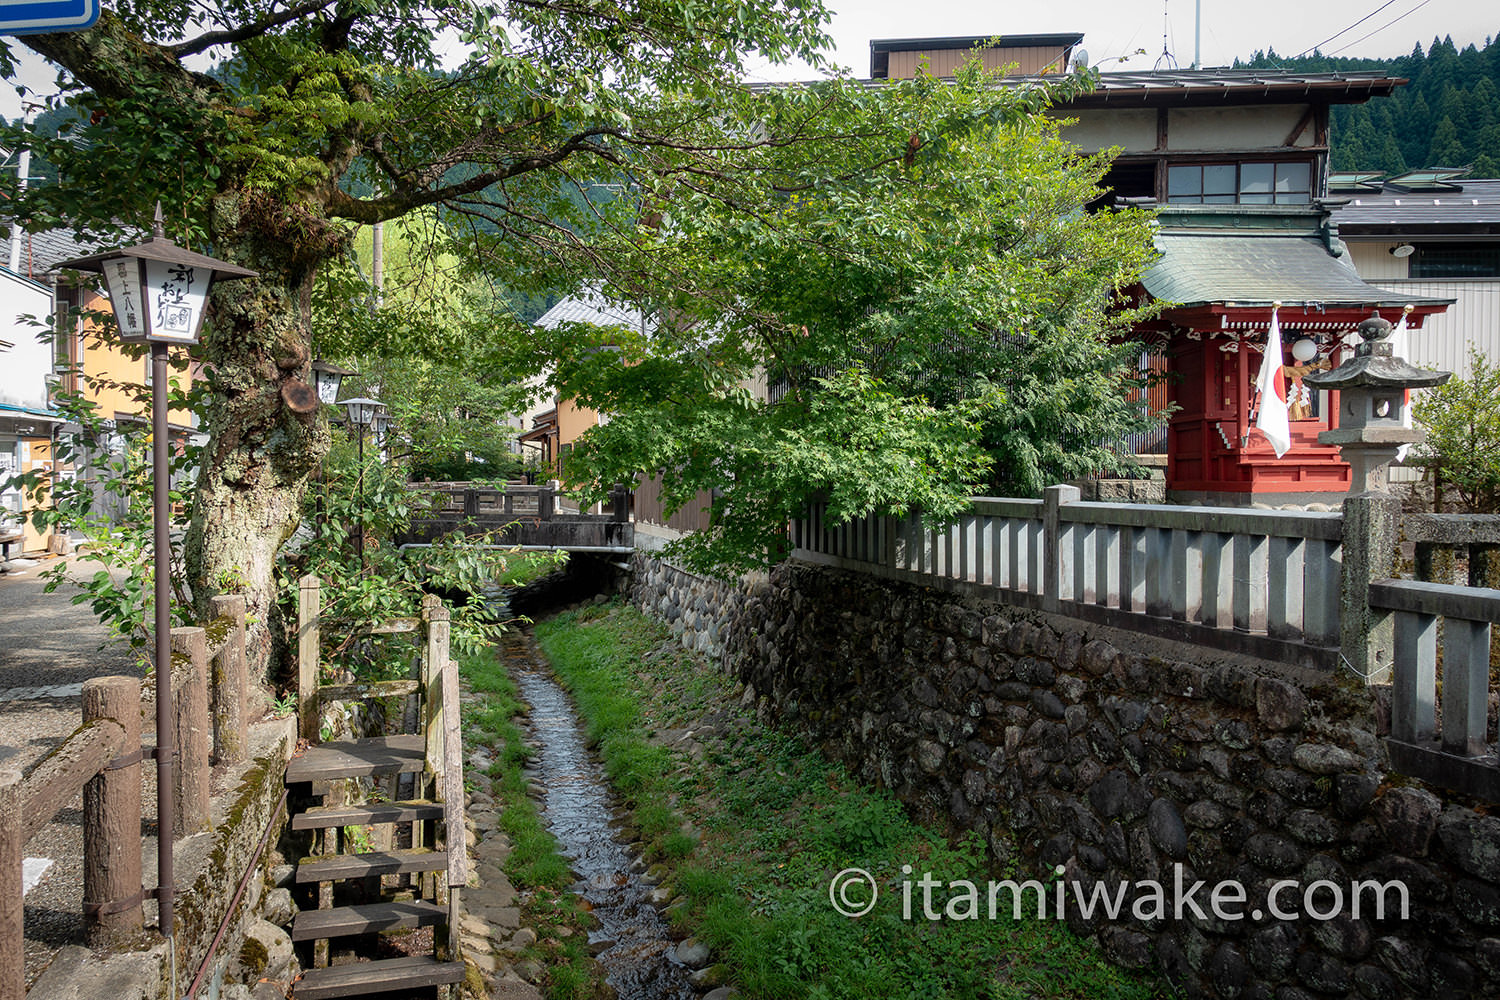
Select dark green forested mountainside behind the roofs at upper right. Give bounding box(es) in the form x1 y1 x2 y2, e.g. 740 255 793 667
1235 37 1500 177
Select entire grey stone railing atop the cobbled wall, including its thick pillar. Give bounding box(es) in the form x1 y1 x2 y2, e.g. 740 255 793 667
792 486 1500 802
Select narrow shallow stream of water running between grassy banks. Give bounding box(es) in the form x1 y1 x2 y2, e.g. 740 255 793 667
506 634 698 1000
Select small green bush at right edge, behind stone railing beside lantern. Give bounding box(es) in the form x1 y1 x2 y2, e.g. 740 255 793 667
1412 346 1500 514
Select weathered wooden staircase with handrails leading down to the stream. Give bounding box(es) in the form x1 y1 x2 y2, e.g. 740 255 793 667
287 590 468 1000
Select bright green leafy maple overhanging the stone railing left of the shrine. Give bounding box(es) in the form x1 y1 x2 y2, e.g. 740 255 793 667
555 64 1154 571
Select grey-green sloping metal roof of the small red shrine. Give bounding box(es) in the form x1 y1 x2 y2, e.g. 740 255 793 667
1143 229 1446 307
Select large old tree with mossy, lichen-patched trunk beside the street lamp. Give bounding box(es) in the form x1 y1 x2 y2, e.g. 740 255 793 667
0 0 846 671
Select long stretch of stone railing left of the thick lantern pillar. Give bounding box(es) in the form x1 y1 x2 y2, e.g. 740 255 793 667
792 486 1341 667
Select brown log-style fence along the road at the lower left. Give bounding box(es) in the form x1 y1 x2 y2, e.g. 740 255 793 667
0 595 248 1000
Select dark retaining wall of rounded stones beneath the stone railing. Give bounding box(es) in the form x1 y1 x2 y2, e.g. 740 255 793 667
708 561 1500 1000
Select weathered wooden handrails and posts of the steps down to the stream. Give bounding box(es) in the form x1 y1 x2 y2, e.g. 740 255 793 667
297 574 468 955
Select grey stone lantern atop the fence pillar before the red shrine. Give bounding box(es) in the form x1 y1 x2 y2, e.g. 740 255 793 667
1304 316 1454 496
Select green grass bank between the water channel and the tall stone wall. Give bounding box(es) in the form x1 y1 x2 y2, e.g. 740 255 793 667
537 604 1167 1000
